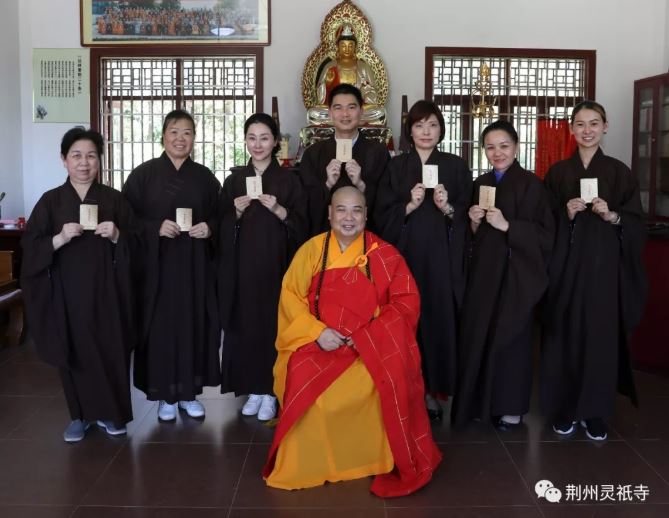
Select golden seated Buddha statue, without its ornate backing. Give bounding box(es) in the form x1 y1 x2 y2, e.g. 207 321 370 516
307 25 386 124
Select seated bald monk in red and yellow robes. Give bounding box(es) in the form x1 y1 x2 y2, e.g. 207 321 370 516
263 186 441 497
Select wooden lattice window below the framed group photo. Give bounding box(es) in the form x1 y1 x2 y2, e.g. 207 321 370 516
91 48 262 189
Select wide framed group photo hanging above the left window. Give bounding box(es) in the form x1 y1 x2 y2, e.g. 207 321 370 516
79 0 270 47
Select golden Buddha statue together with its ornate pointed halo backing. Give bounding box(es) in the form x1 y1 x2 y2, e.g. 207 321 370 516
302 0 388 125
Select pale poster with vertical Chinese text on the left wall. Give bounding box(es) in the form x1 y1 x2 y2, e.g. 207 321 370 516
33 49 90 124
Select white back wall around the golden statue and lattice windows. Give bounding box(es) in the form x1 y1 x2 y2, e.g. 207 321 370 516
10 0 669 217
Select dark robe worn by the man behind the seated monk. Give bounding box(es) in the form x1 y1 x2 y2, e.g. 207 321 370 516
300 133 390 237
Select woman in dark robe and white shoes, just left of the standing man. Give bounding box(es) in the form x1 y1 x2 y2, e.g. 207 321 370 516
219 113 307 421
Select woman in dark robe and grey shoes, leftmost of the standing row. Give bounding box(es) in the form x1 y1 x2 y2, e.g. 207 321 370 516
21 127 134 442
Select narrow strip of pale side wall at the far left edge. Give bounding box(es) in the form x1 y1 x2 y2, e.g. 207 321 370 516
0 0 23 218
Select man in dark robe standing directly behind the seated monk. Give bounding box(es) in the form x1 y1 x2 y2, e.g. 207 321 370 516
300 83 389 236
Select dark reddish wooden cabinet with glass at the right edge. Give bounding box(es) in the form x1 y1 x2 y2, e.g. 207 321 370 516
632 73 669 220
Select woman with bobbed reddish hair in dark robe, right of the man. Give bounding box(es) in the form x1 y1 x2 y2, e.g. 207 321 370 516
374 101 472 419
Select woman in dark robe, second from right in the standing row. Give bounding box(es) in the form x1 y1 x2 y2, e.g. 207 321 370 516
452 120 555 429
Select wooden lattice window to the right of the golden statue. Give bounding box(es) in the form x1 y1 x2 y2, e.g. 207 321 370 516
425 47 596 177
